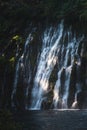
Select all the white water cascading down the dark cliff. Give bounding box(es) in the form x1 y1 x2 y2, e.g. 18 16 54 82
12 21 84 109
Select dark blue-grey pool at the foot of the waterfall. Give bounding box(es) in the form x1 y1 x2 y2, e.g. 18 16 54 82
14 109 87 130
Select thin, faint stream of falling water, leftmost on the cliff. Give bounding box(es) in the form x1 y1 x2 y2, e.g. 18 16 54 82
11 33 33 107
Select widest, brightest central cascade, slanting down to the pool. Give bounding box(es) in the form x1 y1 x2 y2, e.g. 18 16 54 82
31 23 63 109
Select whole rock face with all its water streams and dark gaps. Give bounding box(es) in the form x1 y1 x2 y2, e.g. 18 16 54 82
11 22 87 109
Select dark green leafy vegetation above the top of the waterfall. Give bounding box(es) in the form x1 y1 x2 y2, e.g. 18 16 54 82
0 0 87 53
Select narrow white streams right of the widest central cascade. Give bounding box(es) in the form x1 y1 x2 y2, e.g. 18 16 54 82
53 35 84 109
